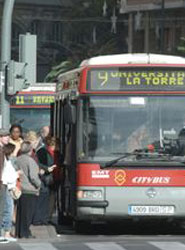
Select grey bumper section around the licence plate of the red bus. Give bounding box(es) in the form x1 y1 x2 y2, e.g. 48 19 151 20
77 187 185 221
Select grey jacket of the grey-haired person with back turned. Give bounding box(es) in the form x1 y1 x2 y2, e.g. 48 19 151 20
17 154 41 195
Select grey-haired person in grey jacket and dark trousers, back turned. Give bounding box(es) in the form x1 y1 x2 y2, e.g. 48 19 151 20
16 142 41 238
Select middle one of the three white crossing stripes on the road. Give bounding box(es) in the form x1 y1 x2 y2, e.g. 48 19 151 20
85 242 126 250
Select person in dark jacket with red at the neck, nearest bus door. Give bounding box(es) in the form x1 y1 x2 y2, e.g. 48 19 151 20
33 137 60 225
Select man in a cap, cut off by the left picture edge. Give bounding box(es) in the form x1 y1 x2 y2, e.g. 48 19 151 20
0 129 9 243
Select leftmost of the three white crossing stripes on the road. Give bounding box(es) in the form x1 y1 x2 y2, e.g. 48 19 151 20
19 243 57 250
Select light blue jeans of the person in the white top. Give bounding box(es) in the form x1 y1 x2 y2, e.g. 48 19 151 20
2 189 14 232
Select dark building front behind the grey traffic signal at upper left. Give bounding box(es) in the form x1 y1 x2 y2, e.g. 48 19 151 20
0 0 75 82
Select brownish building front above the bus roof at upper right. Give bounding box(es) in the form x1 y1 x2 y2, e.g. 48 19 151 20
125 0 185 54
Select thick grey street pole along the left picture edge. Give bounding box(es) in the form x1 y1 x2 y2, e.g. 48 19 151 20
0 0 15 128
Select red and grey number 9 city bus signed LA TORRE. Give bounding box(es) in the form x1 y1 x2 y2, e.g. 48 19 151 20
52 54 185 228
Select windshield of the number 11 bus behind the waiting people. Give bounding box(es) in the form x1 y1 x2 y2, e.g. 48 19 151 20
10 108 50 132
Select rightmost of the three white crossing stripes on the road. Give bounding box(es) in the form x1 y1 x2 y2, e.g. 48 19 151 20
149 241 185 250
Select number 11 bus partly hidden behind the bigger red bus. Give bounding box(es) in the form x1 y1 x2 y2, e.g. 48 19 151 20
10 83 56 132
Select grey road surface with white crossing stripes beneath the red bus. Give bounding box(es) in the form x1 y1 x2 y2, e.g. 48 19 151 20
0 223 185 250
